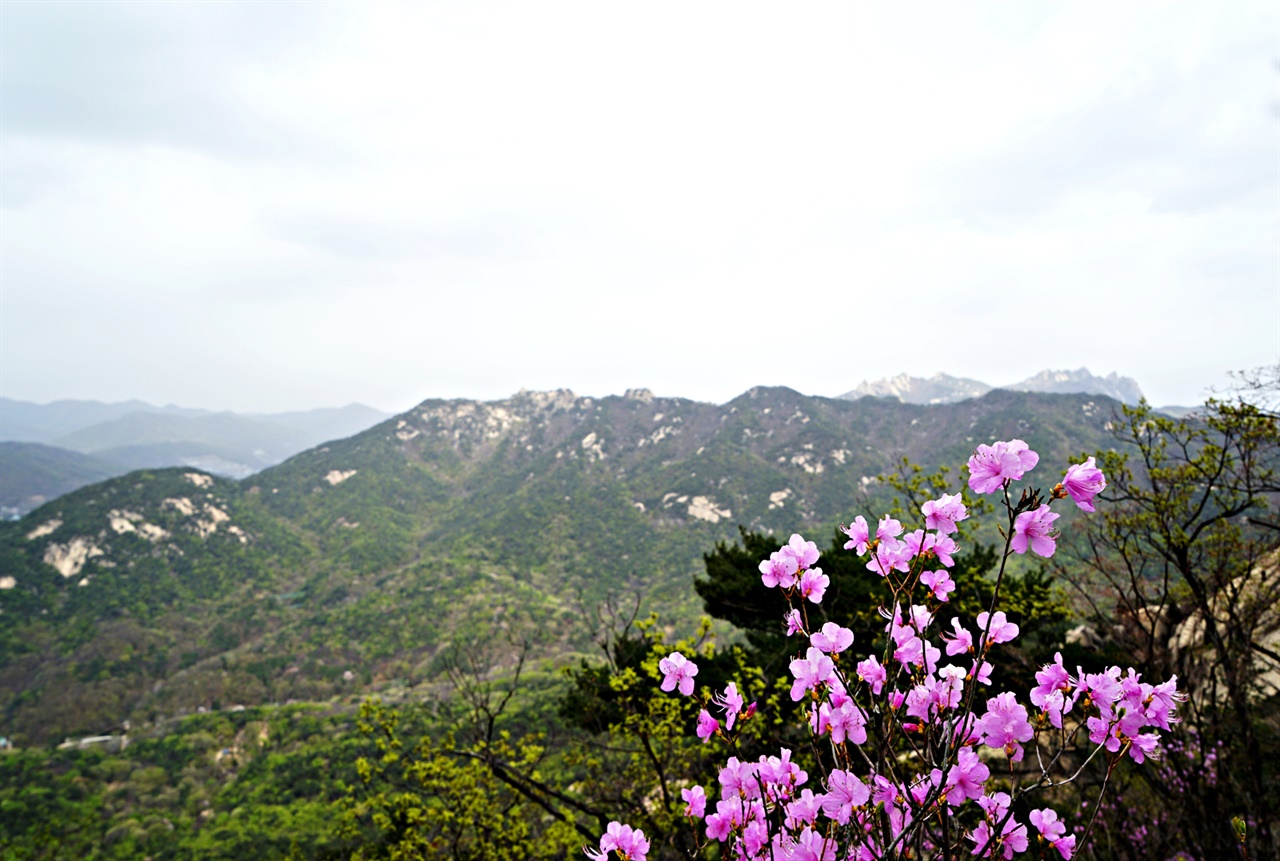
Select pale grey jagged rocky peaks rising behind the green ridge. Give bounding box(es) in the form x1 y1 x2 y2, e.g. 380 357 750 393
840 367 1142 404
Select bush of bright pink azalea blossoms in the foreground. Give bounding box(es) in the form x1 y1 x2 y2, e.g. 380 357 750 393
589 440 1183 861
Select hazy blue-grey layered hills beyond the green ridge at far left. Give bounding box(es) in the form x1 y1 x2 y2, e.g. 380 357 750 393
0 398 388 517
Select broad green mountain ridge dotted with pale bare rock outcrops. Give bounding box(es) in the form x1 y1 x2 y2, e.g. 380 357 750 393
0 388 1136 741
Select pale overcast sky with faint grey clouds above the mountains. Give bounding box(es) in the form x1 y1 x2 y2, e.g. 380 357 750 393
0 0 1280 411
